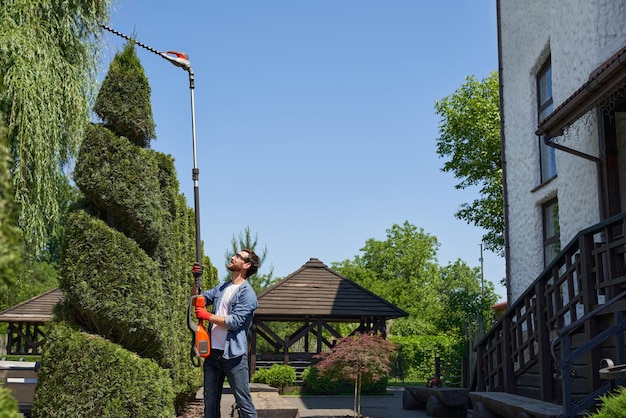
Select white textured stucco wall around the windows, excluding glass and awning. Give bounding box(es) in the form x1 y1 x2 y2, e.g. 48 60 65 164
499 0 626 300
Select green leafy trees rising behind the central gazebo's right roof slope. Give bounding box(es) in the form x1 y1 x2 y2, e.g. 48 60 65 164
332 221 496 340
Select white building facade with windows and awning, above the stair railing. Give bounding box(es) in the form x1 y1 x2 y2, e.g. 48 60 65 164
496 0 626 302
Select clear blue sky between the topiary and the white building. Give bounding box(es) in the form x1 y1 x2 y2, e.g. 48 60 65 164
102 0 506 300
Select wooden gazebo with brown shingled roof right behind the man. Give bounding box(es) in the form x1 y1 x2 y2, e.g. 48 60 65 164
250 258 408 372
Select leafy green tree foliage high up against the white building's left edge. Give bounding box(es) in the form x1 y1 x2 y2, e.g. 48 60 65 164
435 72 504 254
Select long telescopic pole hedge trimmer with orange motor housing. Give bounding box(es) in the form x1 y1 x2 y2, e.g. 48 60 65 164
100 25 211 367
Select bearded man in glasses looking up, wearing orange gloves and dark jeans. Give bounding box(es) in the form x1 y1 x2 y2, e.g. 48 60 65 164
192 248 259 418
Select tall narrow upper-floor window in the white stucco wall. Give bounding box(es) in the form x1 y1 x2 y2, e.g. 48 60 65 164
537 58 556 183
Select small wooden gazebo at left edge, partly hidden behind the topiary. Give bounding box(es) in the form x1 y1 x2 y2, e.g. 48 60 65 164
0 288 63 354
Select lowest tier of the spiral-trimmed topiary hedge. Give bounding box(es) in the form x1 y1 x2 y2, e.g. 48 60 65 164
33 323 175 418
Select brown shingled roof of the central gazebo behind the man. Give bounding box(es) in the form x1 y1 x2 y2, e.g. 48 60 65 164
255 258 408 322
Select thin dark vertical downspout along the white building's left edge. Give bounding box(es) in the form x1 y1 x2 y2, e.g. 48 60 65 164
496 0 513 306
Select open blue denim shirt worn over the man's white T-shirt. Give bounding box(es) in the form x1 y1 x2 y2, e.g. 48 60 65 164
202 280 259 359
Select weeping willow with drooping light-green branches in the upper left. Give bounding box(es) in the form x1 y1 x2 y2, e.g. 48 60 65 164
0 0 111 257
